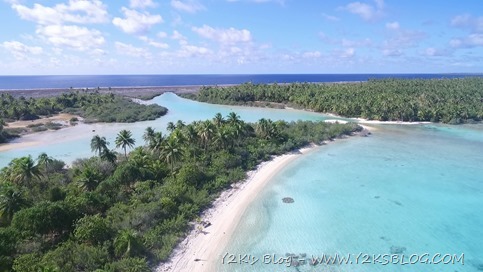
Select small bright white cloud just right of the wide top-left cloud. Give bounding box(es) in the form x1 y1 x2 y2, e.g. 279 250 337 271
112 7 163 34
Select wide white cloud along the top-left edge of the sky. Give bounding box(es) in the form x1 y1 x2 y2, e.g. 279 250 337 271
12 0 108 25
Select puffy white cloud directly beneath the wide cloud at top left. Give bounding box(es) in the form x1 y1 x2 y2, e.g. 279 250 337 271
36 25 105 51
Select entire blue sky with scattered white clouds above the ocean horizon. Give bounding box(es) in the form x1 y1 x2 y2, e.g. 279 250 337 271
0 0 483 75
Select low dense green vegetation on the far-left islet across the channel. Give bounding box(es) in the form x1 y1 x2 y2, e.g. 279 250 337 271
0 91 167 123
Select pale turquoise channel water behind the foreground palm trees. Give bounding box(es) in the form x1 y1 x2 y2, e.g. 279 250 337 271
0 93 343 167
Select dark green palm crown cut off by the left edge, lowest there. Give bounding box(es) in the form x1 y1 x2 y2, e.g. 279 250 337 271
0 185 30 222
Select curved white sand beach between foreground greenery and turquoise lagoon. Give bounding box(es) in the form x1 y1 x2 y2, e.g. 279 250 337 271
156 145 318 272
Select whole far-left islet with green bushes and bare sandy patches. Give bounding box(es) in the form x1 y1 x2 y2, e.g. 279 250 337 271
0 90 168 143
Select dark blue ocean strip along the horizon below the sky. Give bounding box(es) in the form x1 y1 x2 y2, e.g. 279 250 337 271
0 74 482 90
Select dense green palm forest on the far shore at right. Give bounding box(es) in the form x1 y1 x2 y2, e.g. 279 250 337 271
184 77 483 124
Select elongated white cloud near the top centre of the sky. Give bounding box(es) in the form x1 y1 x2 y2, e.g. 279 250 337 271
192 25 252 44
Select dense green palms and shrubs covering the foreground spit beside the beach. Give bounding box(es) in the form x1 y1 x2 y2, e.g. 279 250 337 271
0 113 361 271
